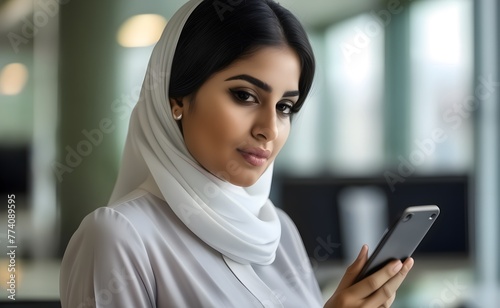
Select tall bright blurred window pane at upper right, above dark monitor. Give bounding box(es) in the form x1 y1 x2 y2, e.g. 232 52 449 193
409 0 474 174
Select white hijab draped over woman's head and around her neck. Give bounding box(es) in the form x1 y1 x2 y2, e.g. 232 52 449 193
109 0 281 265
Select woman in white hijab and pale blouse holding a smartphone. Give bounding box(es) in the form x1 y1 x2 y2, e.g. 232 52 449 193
60 0 413 308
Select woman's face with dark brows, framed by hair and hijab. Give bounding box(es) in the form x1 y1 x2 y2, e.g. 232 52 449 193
173 47 300 187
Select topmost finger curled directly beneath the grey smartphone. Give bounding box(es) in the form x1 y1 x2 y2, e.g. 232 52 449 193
352 260 403 298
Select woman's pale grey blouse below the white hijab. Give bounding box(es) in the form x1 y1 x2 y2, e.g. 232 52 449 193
60 189 323 308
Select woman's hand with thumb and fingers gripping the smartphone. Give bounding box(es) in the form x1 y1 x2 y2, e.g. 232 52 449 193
325 245 413 308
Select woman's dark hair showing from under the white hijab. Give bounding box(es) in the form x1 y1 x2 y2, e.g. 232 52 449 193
169 0 315 112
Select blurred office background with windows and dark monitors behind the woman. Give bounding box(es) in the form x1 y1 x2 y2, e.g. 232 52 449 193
0 0 500 307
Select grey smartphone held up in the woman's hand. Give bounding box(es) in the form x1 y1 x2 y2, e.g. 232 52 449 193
356 205 440 282
